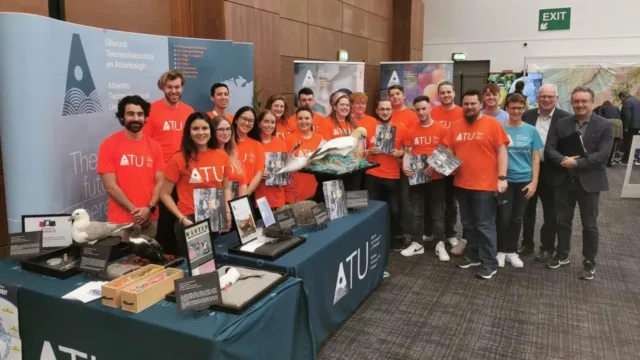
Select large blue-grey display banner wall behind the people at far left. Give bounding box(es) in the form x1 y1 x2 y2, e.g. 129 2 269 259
0 13 253 232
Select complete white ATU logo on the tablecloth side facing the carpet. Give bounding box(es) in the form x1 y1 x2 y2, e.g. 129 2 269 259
333 234 382 305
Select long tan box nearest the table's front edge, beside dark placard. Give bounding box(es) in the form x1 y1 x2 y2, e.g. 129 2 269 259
120 268 184 313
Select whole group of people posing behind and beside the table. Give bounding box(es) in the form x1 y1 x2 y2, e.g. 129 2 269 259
97 70 612 279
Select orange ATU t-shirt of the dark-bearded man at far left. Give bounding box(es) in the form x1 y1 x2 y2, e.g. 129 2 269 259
96 130 164 224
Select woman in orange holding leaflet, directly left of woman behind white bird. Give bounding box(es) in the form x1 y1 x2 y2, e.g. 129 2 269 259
249 110 288 209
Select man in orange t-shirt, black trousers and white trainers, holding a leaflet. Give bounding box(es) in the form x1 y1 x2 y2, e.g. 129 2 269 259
401 95 449 261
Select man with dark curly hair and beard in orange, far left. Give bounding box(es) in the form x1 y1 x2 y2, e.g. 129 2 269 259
97 95 164 238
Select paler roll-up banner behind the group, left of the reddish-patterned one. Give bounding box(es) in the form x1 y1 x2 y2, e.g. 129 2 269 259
293 60 364 116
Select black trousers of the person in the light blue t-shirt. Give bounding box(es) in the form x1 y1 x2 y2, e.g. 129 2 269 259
497 182 529 253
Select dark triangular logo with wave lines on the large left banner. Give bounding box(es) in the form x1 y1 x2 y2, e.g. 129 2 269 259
62 34 102 116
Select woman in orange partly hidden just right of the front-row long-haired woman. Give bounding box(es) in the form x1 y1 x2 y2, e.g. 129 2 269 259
213 116 247 199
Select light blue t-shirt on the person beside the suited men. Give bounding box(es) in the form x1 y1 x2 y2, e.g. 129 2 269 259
503 123 544 183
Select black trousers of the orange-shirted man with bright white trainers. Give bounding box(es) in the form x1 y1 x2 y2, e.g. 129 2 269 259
409 179 445 244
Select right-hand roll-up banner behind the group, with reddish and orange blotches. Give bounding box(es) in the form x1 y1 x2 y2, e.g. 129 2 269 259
380 61 453 108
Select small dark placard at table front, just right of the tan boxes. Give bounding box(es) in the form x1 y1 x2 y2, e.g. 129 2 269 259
175 271 222 312
